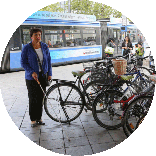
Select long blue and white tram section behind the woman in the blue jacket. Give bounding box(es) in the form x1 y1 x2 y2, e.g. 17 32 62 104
0 11 102 72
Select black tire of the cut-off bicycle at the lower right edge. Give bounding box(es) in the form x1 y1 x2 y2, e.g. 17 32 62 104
122 96 153 137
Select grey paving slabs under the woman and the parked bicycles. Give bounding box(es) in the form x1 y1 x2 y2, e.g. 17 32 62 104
0 55 151 156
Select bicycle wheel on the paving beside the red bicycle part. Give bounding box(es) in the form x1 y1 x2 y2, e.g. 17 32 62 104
92 90 123 130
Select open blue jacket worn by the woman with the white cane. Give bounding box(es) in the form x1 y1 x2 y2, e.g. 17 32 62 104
21 42 52 80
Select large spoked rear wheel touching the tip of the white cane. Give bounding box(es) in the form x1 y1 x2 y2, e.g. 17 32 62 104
44 83 85 123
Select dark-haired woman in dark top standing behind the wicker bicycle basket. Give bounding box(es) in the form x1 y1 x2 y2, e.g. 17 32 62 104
122 36 133 58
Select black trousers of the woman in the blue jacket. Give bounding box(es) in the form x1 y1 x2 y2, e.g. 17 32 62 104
26 72 46 121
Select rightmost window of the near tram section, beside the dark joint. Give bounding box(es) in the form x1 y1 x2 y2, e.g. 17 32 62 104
83 28 96 46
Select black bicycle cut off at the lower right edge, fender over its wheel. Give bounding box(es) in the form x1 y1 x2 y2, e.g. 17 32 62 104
122 75 156 137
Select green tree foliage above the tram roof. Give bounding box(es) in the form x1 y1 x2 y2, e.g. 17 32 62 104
40 0 122 19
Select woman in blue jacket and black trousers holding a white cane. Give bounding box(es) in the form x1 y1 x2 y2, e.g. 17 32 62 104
21 29 52 127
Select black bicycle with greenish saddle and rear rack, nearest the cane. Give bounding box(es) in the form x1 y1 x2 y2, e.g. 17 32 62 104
43 71 103 123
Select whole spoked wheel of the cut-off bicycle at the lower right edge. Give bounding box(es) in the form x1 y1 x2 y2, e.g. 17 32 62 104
122 96 153 137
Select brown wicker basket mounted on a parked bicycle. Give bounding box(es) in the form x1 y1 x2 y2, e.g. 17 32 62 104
112 59 127 75
